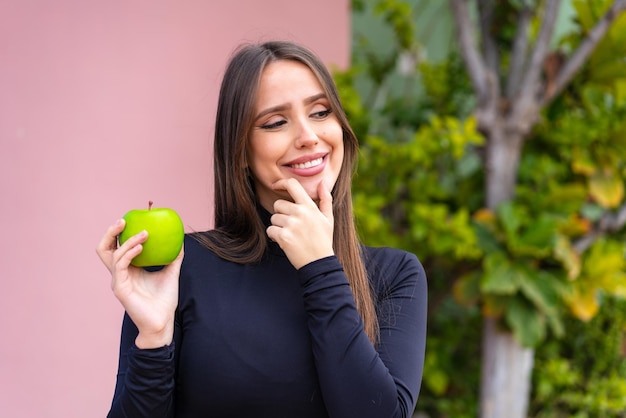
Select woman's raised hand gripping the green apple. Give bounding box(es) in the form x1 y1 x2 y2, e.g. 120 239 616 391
96 219 184 348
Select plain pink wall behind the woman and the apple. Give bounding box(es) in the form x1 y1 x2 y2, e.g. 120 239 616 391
0 0 350 418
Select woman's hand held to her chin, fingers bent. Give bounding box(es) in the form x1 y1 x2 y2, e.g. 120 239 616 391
267 178 335 269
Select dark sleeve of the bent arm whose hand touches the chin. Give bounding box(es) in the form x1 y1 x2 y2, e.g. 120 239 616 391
299 252 427 418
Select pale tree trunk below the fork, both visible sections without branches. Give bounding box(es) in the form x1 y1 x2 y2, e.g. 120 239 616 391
480 127 534 418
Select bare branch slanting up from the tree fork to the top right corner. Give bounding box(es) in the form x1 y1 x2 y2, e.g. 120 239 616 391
542 0 626 105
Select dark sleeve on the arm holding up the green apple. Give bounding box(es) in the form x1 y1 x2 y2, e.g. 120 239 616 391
107 314 176 418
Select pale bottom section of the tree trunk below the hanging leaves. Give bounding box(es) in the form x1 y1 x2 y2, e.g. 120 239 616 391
480 318 535 418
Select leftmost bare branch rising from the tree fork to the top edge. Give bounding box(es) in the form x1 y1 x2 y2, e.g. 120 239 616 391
450 0 489 103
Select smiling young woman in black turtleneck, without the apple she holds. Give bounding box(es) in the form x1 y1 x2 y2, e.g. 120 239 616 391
97 42 427 418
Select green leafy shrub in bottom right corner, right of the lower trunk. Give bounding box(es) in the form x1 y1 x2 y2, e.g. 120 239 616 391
531 298 626 418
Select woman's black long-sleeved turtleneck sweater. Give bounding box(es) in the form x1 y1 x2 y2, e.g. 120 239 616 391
108 217 427 418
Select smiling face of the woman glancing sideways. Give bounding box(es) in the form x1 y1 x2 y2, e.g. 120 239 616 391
247 60 343 212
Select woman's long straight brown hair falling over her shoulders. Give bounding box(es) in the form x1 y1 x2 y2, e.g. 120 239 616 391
195 41 378 343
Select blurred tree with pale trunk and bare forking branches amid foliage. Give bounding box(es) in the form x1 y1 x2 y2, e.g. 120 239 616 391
450 0 626 418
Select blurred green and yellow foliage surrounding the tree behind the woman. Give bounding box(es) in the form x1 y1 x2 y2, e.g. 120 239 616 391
335 0 626 418
